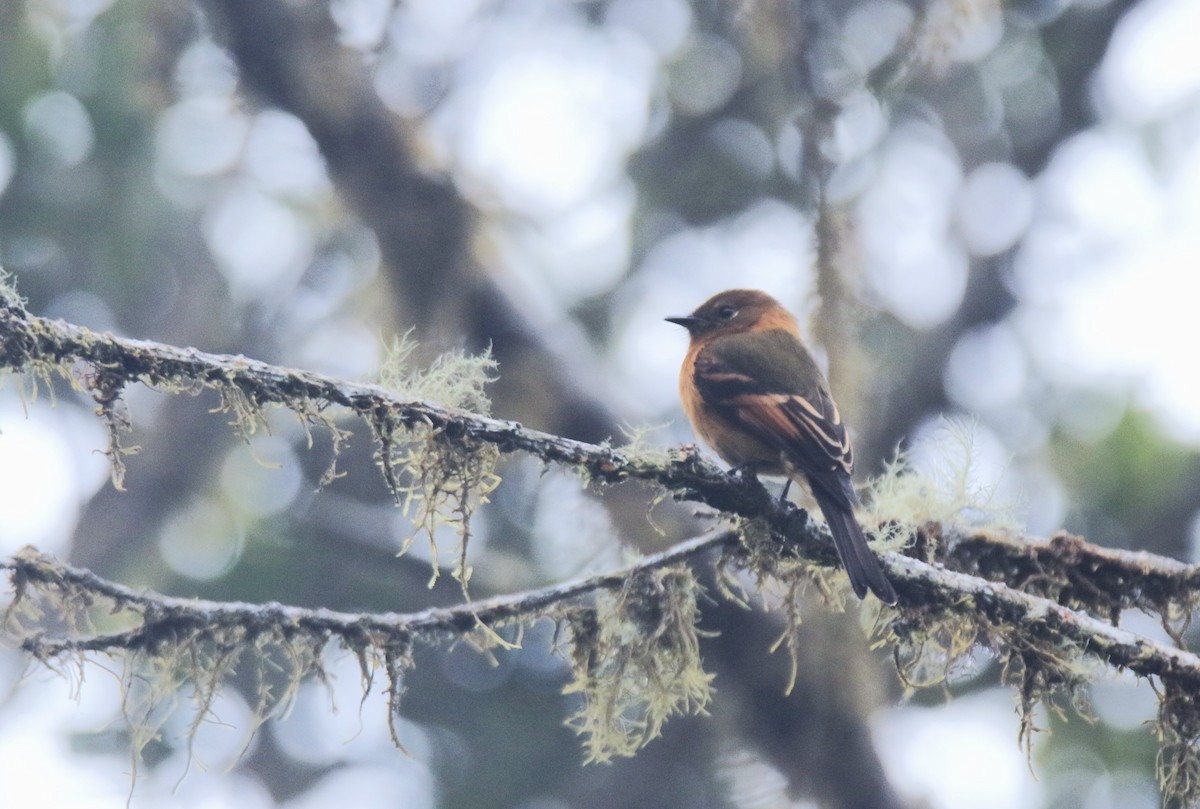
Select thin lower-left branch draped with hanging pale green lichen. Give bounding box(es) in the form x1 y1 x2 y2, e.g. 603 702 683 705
0 529 739 765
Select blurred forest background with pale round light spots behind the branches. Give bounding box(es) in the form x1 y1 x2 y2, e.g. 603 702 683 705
0 0 1200 809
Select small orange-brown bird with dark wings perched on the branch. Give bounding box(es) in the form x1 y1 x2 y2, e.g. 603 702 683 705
665 289 896 604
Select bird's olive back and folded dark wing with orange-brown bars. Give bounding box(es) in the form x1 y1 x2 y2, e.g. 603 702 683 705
695 330 854 507
